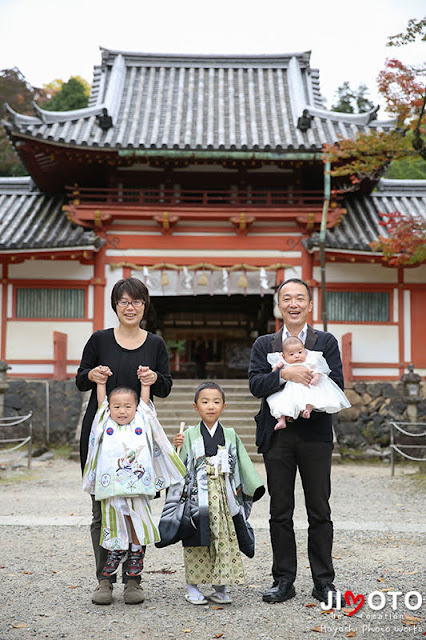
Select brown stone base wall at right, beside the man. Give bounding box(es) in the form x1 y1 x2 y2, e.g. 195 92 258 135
334 382 426 457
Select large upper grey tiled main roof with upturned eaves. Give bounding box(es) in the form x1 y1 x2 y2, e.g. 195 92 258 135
2 49 394 153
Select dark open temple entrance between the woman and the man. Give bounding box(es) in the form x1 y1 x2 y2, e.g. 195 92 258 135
147 295 275 378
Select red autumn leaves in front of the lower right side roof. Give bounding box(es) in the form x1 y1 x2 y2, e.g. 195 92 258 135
370 211 426 267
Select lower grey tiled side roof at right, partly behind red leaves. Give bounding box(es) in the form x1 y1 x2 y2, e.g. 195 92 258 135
308 179 426 252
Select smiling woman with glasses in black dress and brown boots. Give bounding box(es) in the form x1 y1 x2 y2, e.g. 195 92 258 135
76 278 172 604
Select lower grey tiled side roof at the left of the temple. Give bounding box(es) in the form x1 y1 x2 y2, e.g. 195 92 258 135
0 178 99 252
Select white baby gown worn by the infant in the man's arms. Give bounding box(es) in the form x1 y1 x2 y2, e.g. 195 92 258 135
266 350 351 420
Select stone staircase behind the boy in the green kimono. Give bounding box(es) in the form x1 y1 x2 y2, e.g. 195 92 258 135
155 379 263 462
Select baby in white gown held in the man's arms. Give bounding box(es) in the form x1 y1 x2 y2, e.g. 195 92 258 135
266 336 351 431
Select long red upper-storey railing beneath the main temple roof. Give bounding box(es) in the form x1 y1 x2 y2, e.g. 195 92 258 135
67 187 330 208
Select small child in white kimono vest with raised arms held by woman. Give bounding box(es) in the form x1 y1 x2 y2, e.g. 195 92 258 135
83 367 186 578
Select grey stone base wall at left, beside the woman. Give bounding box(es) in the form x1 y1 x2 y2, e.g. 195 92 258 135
0 378 83 445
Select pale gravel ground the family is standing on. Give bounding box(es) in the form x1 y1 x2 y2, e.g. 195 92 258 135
0 453 426 640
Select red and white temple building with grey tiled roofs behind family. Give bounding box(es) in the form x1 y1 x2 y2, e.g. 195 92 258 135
0 49 426 380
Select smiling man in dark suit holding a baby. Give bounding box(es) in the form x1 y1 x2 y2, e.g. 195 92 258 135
249 278 344 606
